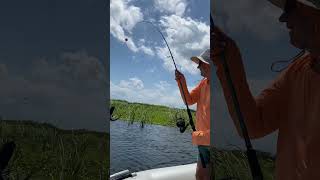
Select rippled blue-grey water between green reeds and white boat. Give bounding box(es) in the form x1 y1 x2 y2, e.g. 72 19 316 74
110 120 198 174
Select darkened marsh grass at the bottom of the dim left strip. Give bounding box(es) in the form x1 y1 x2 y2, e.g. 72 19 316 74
0 120 109 180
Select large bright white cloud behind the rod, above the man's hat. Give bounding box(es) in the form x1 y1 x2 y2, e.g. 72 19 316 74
157 15 210 74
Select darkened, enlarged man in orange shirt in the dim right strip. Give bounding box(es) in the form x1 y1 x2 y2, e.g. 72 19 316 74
211 0 320 180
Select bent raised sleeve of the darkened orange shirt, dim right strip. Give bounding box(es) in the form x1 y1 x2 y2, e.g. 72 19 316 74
217 47 289 138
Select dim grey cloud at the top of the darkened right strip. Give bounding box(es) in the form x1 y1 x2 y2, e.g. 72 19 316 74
215 0 284 40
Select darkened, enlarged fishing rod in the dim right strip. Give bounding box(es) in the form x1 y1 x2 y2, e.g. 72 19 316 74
210 13 263 180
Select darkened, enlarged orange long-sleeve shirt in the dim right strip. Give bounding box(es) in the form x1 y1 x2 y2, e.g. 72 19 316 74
217 53 320 180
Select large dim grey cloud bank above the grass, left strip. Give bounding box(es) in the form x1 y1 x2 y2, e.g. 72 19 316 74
0 50 108 131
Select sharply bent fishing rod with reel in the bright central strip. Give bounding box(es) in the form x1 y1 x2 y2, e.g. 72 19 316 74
125 20 206 168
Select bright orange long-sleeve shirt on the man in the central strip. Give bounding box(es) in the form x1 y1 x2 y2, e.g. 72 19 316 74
177 78 210 146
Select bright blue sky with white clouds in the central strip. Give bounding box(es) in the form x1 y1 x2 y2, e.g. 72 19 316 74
110 0 210 107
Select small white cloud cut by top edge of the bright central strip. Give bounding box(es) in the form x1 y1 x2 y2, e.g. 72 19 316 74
154 0 187 16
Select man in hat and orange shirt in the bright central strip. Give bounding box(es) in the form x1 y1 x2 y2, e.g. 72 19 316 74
175 49 210 180
